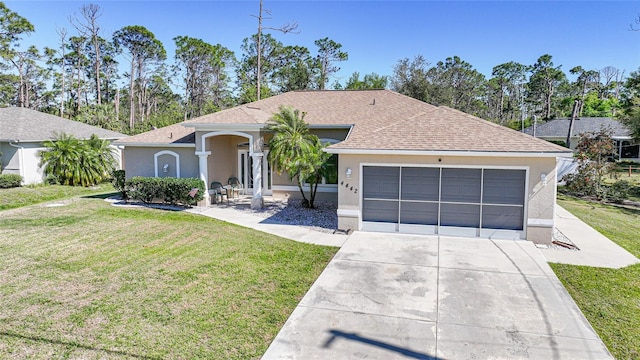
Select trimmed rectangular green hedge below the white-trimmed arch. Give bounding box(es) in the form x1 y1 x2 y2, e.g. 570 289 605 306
125 176 204 205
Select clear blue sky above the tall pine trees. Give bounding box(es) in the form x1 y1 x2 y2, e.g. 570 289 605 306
5 0 640 83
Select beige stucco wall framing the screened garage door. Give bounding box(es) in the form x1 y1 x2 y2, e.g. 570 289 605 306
338 155 556 243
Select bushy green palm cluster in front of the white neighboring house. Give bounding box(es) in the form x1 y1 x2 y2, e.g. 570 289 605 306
40 133 116 186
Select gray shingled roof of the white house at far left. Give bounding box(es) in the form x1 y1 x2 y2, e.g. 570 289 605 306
0 107 127 142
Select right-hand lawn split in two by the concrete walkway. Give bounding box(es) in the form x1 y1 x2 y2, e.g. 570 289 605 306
551 196 640 359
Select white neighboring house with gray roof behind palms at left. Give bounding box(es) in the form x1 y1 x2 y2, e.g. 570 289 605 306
0 107 126 184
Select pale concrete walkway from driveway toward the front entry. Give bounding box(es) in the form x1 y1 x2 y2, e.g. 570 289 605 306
187 207 348 247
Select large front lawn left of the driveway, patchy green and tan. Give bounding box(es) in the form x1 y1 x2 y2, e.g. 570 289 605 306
0 198 337 359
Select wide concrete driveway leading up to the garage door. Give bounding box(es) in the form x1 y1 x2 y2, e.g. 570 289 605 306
263 232 612 359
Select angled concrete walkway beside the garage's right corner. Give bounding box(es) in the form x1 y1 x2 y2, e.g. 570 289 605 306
540 205 640 269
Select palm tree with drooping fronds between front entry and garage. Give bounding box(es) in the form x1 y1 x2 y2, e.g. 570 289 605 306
266 106 331 208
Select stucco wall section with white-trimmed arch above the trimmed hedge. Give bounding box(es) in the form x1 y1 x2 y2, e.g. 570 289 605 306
123 146 199 179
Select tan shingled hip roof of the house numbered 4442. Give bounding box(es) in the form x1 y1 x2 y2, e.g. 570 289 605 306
120 90 570 153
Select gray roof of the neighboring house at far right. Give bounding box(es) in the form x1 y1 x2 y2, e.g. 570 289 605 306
524 117 631 138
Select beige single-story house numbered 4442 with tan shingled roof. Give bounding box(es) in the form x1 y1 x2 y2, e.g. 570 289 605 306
116 90 571 243
